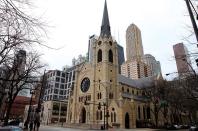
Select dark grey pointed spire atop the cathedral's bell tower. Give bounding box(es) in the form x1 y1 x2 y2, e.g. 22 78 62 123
100 0 111 37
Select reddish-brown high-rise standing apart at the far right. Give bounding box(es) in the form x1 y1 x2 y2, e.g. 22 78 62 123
173 43 193 76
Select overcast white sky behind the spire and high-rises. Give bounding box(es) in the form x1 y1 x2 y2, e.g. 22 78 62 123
33 0 198 78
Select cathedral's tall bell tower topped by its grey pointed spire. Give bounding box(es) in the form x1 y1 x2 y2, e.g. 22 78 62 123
92 1 118 120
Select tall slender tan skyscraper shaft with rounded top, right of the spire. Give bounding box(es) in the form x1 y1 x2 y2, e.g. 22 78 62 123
126 24 144 61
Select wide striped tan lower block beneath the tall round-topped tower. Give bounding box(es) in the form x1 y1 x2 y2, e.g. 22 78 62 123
121 60 151 79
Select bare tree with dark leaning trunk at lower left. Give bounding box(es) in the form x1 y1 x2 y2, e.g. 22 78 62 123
1 53 45 125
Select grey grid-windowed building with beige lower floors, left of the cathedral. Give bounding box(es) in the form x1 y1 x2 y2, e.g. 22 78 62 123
38 66 77 124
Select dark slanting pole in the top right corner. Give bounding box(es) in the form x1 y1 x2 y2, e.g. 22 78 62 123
185 0 198 46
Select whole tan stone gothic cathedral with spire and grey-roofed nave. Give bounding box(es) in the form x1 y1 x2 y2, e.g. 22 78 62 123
67 1 152 128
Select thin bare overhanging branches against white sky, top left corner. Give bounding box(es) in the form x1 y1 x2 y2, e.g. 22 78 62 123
0 0 44 65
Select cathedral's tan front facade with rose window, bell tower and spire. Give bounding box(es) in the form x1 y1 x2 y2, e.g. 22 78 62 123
67 1 118 125
